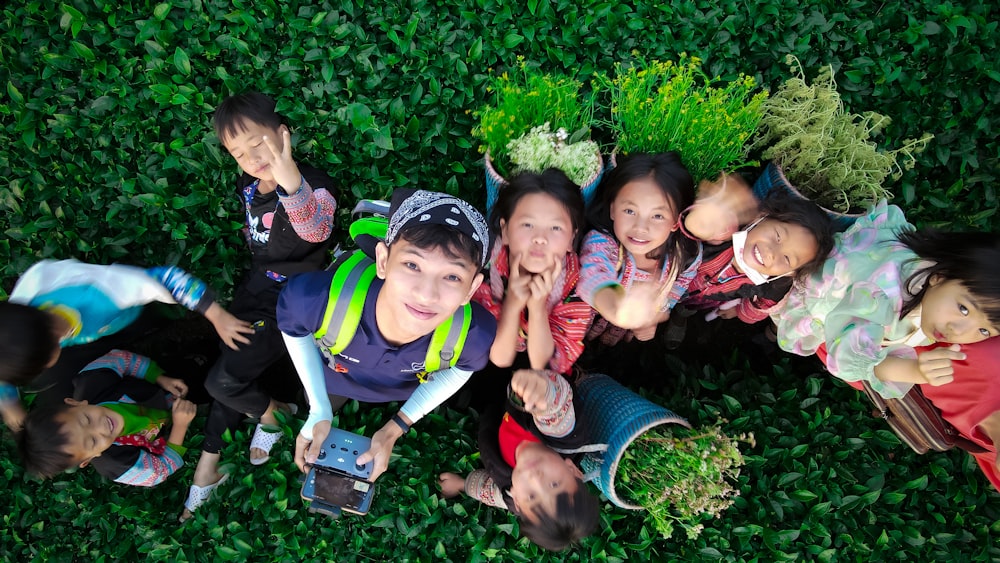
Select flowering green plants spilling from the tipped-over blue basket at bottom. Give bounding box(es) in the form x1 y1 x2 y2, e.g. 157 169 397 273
617 425 753 539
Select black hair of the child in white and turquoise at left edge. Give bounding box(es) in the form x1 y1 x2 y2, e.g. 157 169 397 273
0 301 59 385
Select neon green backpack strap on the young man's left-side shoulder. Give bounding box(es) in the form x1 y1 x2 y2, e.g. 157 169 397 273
313 252 375 355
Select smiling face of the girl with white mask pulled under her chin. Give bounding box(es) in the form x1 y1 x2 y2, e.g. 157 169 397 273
743 218 819 276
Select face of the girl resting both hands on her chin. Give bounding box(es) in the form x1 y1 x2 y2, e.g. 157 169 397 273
500 193 576 274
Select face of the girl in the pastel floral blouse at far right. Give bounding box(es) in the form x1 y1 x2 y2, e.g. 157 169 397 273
920 277 1000 344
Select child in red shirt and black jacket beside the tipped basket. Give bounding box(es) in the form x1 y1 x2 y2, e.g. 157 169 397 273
440 370 600 551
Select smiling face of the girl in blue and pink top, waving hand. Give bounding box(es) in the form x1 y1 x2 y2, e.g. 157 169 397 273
611 178 677 257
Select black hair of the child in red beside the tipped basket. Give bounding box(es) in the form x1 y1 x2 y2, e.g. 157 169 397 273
517 479 601 551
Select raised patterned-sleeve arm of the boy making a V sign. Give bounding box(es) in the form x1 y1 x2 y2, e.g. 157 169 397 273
264 127 337 242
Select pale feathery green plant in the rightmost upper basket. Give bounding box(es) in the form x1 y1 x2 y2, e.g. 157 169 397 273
753 55 934 213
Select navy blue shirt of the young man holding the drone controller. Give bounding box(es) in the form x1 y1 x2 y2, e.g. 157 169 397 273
277 271 496 403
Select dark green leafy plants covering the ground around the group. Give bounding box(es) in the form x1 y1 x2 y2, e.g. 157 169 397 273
0 0 1000 561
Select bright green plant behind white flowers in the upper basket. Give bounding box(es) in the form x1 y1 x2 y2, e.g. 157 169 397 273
472 57 596 176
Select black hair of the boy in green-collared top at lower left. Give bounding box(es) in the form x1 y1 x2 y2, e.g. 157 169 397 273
16 404 76 479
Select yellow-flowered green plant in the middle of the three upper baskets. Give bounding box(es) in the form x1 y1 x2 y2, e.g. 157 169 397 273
597 53 767 180
